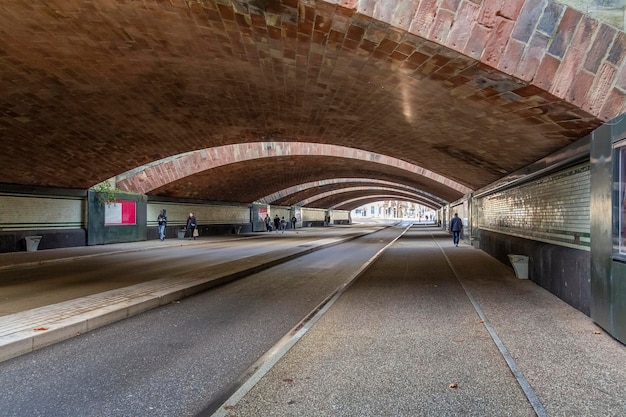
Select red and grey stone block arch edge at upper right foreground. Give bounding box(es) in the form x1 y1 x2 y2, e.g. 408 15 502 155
336 0 626 121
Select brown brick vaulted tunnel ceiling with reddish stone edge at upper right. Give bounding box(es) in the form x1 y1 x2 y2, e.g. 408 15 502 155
0 0 626 208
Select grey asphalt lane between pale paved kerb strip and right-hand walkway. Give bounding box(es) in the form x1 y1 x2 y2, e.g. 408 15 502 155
0 224 403 417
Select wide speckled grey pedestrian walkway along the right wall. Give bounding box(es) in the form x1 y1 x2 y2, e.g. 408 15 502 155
206 228 626 417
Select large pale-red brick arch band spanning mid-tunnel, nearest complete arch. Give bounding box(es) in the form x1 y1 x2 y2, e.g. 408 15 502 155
116 142 472 194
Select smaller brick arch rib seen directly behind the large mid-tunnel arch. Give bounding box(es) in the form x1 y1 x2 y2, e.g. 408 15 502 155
258 178 447 206
